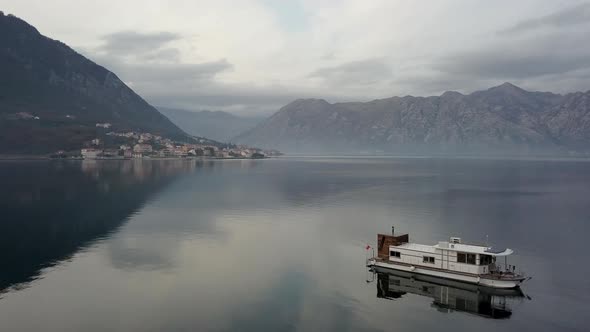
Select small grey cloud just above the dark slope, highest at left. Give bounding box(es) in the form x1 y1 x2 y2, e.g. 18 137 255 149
100 31 181 55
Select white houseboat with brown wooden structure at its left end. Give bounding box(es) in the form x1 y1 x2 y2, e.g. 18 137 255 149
367 227 527 288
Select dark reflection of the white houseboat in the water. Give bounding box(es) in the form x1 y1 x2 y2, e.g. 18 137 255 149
369 267 525 319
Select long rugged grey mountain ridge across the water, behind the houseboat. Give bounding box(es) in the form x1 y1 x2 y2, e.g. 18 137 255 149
234 83 590 153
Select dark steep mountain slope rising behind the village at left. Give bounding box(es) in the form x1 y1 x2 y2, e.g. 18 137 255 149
0 12 187 154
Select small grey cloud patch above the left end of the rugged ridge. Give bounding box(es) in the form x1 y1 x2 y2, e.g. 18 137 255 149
309 59 392 85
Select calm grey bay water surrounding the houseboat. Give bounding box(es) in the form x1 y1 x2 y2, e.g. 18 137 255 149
0 157 590 331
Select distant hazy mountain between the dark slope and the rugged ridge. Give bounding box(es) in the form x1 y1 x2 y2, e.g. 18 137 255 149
158 107 263 142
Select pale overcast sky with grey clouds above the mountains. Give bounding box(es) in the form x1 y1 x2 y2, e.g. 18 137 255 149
0 0 590 115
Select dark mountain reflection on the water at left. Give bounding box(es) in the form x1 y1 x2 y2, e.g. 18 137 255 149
0 161 195 293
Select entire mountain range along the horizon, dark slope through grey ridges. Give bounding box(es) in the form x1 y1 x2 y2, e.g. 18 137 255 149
0 12 590 154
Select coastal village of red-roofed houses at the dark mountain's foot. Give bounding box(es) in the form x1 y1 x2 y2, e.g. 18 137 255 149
61 123 281 159
